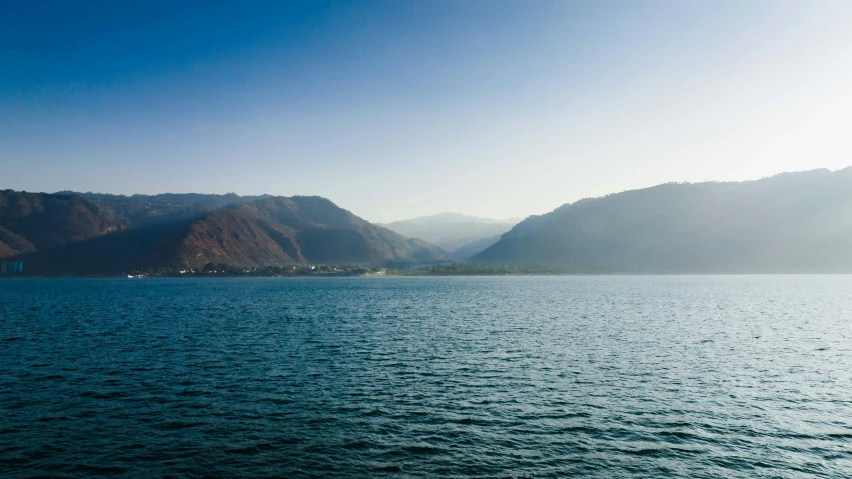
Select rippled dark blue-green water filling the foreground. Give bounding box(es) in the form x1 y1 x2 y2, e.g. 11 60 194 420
0 276 852 478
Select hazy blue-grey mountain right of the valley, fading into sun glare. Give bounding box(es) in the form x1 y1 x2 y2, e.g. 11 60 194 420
471 168 852 273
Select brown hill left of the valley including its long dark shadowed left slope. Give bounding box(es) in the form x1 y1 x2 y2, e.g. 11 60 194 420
19 196 444 275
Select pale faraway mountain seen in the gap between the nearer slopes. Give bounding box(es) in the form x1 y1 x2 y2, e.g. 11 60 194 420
382 213 518 259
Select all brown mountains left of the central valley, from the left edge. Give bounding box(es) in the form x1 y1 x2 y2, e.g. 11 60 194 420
0 190 445 275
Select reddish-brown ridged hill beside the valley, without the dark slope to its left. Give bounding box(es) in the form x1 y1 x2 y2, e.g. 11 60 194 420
179 196 444 267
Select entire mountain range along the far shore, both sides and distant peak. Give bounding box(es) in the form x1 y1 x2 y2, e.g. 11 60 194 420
0 168 852 275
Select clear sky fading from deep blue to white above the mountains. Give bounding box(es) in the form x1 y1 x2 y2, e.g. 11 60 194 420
0 0 852 221
